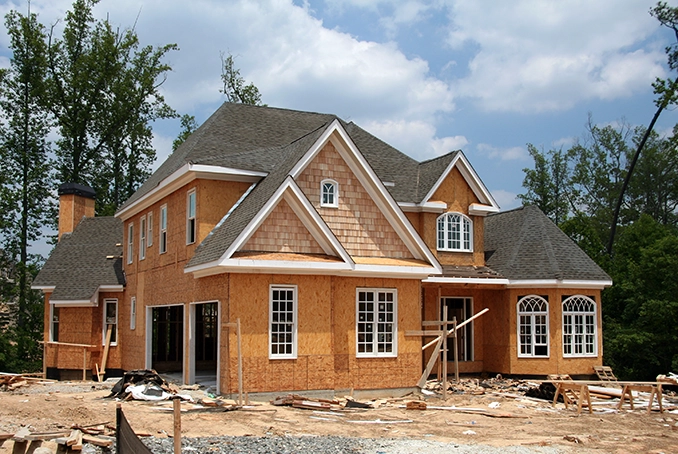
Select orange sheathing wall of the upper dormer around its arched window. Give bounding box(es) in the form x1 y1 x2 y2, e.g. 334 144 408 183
424 168 485 266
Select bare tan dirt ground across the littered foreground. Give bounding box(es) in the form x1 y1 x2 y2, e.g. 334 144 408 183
0 382 678 454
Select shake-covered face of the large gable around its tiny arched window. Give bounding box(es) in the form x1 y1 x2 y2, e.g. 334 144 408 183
297 143 413 258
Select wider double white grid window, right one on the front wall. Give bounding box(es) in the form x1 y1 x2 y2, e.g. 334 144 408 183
355 287 398 358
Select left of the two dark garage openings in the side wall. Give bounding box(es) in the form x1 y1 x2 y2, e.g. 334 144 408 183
151 306 184 374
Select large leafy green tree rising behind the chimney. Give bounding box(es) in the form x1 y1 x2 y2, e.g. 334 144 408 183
47 0 177 214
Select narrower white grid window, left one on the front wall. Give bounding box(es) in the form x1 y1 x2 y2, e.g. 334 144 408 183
269 286 297 359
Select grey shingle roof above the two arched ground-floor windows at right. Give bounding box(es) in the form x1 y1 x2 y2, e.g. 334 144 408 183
485 206 612 285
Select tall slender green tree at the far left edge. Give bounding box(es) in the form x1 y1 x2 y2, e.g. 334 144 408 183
0 11 51 371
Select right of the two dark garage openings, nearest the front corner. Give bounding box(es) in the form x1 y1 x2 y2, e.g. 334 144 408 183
193 302 218 384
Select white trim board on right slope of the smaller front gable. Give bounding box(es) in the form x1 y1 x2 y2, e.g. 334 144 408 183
283 183 353 264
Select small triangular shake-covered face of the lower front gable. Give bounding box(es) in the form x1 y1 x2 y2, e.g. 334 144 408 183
240 199 325 254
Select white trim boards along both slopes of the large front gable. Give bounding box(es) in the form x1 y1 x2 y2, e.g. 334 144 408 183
290 120 442 274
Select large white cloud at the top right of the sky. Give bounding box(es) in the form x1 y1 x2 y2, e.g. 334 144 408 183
448 0 665 112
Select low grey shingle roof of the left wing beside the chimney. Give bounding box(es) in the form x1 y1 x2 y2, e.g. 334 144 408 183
32 216 125 305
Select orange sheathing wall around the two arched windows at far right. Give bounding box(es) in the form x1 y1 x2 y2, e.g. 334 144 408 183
507 288 603 375
